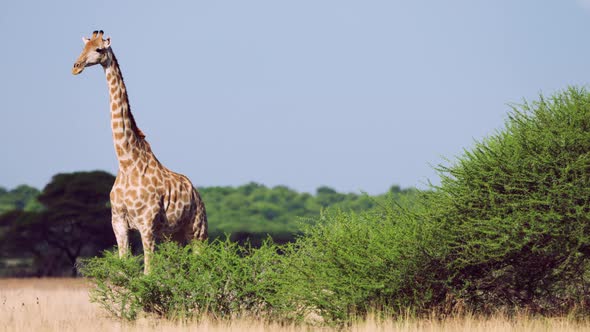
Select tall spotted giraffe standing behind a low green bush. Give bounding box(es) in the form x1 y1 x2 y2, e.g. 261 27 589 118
72 30 207 274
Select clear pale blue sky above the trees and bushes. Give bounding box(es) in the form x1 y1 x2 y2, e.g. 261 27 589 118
0 0 590 193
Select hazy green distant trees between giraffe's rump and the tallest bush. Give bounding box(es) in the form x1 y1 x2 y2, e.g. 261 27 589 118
201 182 417 245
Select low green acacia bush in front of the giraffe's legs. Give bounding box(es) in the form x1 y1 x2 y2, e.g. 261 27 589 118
81 240 280 319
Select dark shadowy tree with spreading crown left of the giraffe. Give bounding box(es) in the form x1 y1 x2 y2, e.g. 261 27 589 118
0 171 115 275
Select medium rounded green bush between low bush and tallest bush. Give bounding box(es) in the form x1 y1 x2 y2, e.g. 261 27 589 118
277 205 445 324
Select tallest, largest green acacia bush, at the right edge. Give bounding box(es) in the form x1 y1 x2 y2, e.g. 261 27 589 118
432 88 590 312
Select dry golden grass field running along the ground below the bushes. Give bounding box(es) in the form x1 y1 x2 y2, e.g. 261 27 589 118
0 279 590 332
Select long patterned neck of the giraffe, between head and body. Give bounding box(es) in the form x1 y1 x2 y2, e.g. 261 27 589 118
104 49 151 172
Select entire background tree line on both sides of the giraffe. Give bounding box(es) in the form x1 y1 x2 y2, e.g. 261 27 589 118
0 171 417 276
